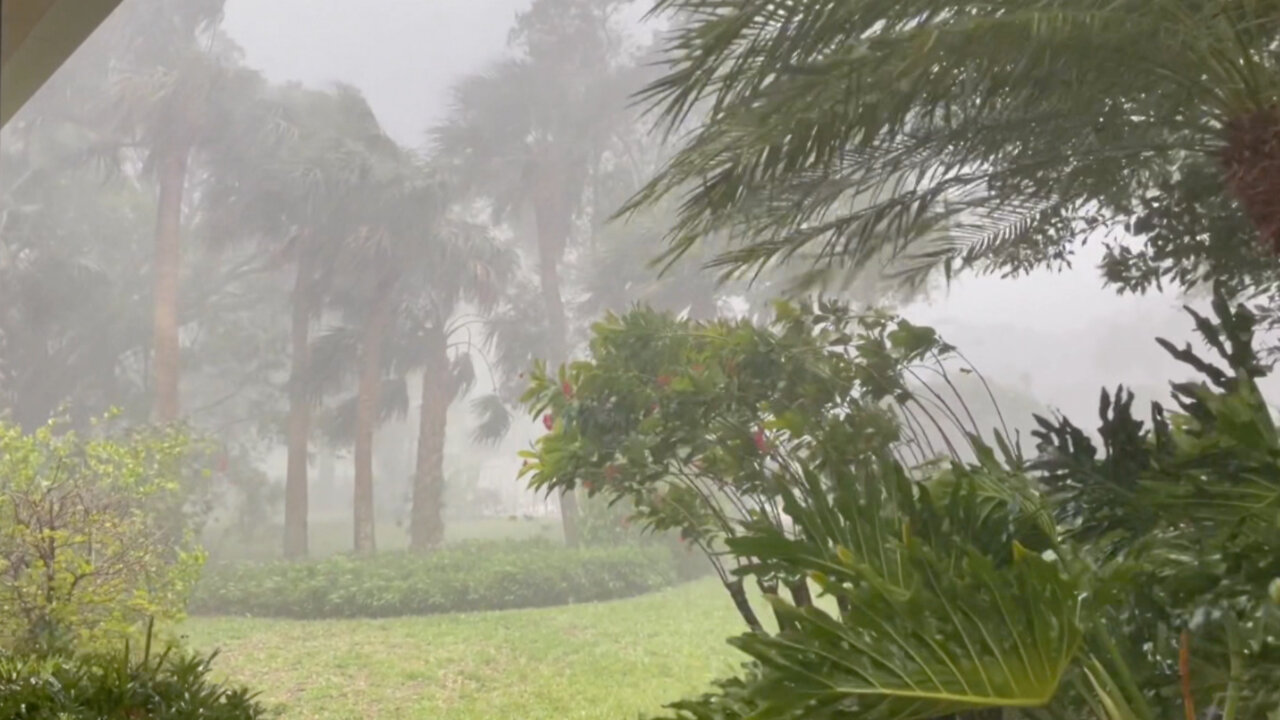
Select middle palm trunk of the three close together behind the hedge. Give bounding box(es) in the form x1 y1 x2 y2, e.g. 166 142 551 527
352 283 392 555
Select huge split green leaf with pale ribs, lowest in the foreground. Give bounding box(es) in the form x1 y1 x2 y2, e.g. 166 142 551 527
735 548 1080 719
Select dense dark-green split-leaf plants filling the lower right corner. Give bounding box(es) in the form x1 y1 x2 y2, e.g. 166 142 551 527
640 295 1280 720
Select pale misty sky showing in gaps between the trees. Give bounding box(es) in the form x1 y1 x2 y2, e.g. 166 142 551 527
217 0 1189 416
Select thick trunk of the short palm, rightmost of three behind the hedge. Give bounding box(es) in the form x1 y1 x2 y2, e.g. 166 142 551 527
408 332 453 552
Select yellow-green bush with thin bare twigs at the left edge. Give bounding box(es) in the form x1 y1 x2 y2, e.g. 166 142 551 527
0 423 204 652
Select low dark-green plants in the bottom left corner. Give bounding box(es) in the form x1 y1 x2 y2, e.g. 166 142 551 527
0 627 268 720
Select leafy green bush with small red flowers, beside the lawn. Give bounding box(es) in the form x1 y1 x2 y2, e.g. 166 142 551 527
522 302 998 624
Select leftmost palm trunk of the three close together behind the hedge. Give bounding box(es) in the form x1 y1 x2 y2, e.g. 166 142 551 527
284 252 311 557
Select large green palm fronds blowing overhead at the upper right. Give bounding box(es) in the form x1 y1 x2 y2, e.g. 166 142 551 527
630 0 1280 286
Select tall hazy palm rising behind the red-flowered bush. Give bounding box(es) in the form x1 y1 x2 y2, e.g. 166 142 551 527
435 0 640 544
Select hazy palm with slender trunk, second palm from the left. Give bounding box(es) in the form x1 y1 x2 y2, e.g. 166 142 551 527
206 86 381 557
